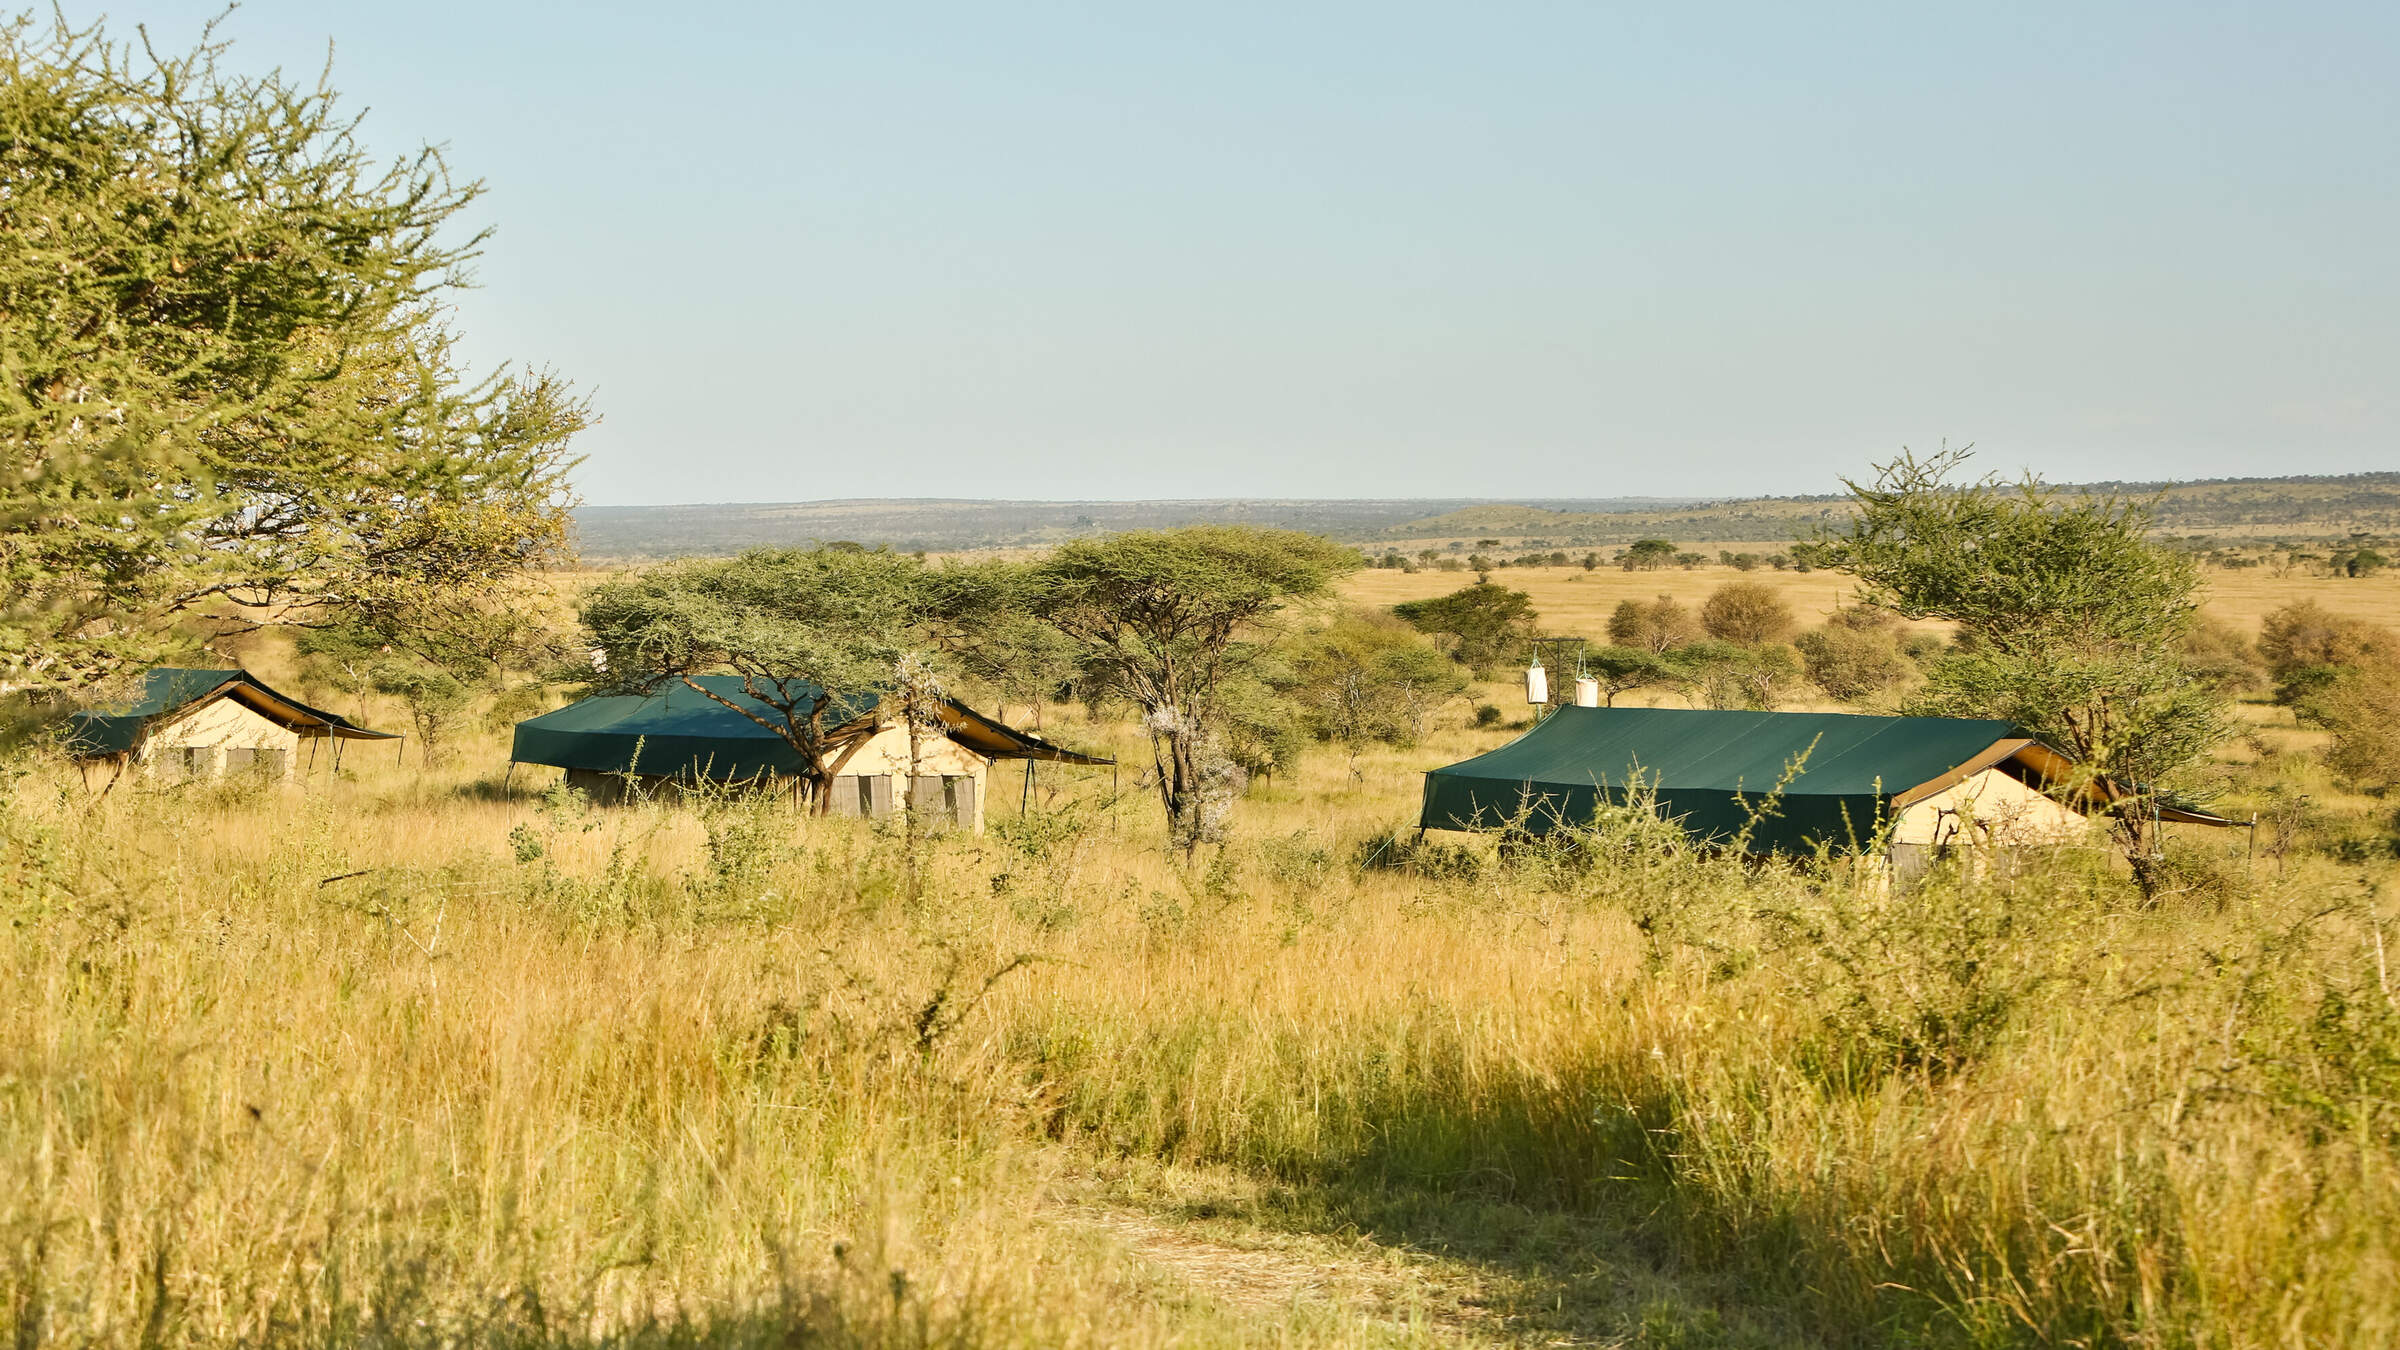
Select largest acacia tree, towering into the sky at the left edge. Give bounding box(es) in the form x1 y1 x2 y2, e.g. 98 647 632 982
0 17 590 689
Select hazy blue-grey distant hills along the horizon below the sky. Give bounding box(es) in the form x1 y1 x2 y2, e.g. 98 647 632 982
576 473 2400 562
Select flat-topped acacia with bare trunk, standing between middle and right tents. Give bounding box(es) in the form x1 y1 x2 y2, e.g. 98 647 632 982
1027 526 1358 855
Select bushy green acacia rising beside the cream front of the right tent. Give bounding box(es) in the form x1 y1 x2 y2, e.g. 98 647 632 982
1826 449 2225 889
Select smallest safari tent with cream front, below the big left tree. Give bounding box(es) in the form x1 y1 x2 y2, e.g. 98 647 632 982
67 668 396 781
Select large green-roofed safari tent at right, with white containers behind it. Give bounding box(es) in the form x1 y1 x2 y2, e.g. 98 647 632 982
1418 706 2234 872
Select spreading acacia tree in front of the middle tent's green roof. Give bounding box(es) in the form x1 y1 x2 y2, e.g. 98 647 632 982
581 548 926 810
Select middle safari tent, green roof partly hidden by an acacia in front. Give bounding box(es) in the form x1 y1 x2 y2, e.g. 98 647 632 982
509 675 1109 831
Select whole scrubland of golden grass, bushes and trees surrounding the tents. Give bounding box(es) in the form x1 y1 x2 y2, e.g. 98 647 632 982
14 17 2400 1350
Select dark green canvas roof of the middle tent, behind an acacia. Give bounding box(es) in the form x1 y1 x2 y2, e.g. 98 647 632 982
509 675 1109 783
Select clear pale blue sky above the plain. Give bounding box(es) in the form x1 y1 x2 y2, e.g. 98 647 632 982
84 0 2400 504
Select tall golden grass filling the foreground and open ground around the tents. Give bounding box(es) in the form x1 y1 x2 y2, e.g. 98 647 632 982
0 569 2400 1350
